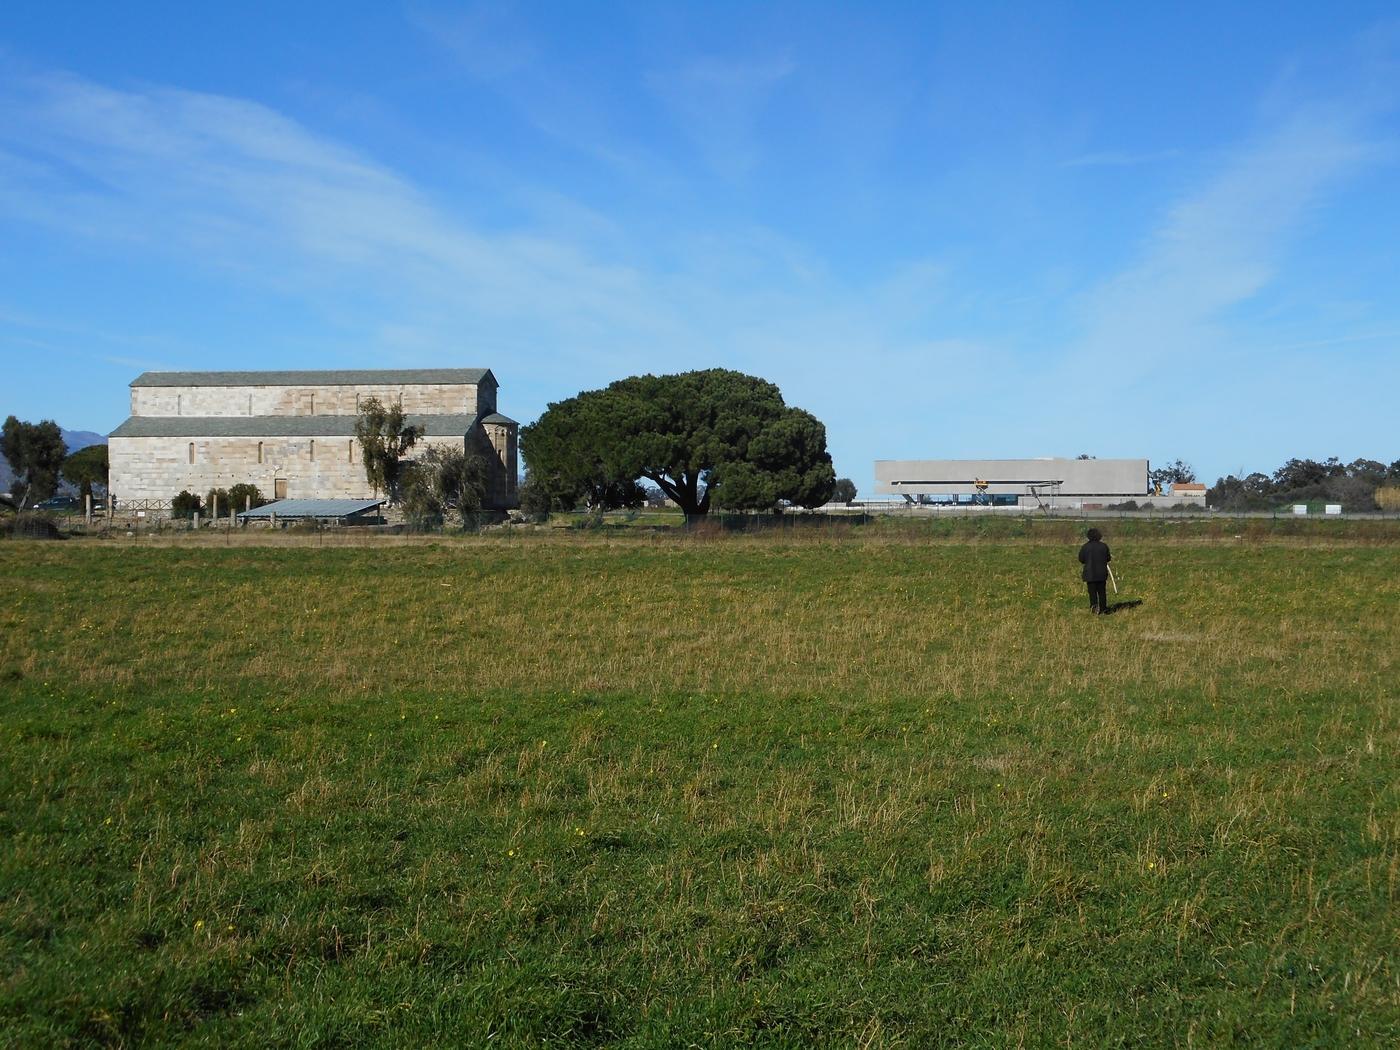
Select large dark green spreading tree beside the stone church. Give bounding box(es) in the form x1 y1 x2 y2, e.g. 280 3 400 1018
521 368 836 517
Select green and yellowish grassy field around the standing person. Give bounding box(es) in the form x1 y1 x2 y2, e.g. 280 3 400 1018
0 524 1400 1047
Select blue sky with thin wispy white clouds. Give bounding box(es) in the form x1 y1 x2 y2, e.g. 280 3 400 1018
0 0 1400 491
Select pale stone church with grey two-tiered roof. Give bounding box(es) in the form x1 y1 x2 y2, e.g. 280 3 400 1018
108 368 519 510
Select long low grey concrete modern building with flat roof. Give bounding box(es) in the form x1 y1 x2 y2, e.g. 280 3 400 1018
875 458 1151 510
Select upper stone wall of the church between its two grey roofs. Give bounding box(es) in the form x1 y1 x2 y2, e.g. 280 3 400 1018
132 382 496 416
